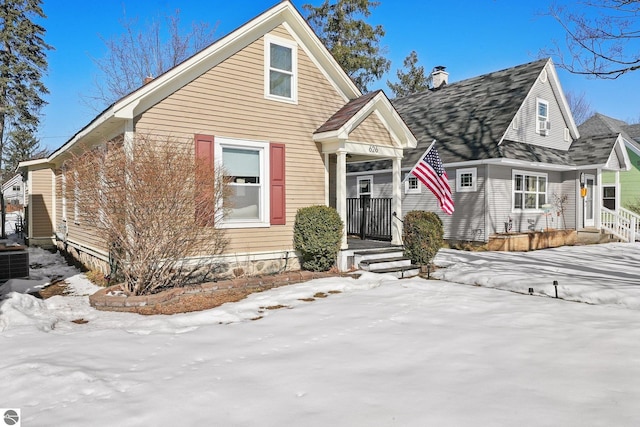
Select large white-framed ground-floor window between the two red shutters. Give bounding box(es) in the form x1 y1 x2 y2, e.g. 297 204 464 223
214 138 269 227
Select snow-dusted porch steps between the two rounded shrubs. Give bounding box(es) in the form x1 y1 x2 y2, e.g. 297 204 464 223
353 246 420 279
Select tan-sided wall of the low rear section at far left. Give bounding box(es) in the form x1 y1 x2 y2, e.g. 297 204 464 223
29 168 54 238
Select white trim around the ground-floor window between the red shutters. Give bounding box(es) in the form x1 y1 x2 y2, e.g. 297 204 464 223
214 137 271 228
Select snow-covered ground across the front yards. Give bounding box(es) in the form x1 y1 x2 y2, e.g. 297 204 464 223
0 244 640 426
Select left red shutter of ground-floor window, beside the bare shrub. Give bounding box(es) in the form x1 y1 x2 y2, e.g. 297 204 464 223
194 134 215 226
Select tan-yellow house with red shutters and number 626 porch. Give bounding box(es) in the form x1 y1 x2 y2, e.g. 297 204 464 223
19 1 416 274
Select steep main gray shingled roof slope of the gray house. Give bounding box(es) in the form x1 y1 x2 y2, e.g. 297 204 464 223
392 59 548 167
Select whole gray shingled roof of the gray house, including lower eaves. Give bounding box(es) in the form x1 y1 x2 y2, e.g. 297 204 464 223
348 59 624 172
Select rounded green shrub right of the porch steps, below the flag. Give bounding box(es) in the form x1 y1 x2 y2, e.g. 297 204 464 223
402 211 444 265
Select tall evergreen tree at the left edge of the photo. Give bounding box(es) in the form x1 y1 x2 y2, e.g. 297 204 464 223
0 0 51 237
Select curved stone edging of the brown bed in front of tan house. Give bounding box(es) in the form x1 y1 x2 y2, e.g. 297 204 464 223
89 271 347 313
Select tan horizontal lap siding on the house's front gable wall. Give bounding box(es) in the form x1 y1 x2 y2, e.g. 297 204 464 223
136 27 345 253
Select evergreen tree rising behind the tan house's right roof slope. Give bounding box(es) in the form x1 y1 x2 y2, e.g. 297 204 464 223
302 0 391 92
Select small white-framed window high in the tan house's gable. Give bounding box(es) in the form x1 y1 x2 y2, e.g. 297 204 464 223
264 35 297 102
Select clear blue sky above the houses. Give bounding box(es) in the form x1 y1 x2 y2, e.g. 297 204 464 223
38 0 640 149
